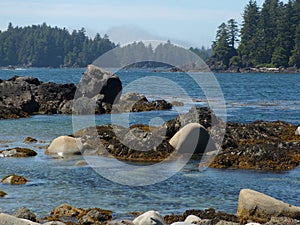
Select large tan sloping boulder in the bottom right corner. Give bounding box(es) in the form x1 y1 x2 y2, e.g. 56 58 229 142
237 189 300 223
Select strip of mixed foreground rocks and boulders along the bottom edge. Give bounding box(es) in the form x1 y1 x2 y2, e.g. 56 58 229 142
0 189 300 225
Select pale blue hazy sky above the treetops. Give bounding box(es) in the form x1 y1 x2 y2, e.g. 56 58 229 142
0 0 288 47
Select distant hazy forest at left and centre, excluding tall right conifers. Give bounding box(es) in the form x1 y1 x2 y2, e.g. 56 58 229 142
0 23 211 67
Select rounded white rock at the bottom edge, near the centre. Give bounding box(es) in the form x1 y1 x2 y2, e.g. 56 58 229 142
133 210 166 225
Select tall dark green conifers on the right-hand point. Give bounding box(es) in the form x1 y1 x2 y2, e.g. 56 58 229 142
208 0 300 70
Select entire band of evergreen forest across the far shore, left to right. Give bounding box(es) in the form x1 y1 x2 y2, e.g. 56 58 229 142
0 0 300 73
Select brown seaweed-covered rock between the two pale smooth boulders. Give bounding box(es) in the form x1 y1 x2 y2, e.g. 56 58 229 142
74 125 174 162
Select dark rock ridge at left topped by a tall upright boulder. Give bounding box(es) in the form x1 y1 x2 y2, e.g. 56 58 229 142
0 65 172 119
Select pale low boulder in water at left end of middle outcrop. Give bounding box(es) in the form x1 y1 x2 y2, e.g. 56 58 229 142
46 136 82 156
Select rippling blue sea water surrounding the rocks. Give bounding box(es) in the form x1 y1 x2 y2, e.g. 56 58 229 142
0 69 300 217
